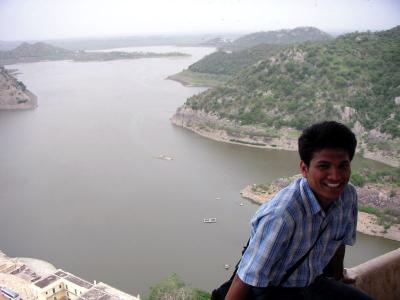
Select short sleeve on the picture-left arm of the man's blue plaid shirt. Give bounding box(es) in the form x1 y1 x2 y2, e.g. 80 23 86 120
237 214 292 287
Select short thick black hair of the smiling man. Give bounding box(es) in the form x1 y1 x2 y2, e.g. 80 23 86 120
299 121 357 166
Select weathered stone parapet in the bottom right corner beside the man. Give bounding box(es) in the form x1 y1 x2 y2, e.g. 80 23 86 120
347 248 400 300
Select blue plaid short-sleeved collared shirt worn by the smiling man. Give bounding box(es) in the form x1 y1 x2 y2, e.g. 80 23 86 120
237 178 357 287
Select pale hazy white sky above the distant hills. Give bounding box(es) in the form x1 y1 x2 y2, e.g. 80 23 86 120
0 0 400 40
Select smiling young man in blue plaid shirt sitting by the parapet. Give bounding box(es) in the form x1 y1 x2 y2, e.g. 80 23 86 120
226 122 372 300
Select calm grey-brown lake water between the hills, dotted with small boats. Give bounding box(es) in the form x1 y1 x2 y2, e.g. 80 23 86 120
0 47 399 294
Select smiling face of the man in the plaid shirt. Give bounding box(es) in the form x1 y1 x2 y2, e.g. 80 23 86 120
300 149 351 209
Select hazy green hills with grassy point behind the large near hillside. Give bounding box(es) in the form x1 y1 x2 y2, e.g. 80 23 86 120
169 27 331 86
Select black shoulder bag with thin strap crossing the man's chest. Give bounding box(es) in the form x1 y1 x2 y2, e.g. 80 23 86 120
211 224 328 300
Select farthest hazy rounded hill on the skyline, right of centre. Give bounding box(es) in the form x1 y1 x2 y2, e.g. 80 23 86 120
226 27 332 50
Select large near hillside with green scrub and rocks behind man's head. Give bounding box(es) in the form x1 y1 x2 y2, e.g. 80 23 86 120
176 26 400 165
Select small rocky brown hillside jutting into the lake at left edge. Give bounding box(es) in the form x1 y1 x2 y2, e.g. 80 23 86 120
0 67 37 109
